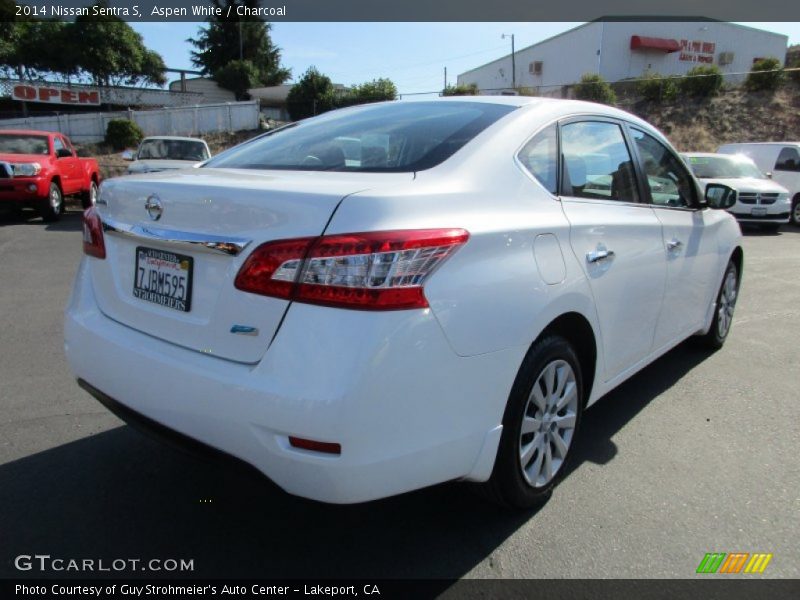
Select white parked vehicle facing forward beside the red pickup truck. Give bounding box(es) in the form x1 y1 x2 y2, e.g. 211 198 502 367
122 135 211 175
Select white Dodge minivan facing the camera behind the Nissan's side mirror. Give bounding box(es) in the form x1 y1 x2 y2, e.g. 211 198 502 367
683 152 792 231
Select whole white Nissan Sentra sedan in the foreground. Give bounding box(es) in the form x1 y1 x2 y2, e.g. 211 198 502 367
65 96 743 507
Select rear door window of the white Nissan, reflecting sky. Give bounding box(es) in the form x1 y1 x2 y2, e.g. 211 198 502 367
561 121 639 202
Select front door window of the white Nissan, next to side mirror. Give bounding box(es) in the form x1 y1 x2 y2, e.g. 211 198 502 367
631 129 697 208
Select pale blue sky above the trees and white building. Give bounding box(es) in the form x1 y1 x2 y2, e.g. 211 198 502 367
131 23 800 94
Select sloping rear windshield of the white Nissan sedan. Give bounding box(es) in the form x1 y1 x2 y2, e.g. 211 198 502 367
205 102 515 172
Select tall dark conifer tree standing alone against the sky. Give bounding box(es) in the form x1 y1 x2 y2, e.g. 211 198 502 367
187 0 291 86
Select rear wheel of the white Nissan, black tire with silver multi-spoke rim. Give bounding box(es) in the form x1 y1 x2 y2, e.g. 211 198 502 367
481 335 585 509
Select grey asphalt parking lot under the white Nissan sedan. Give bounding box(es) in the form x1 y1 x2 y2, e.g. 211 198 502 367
0 209 800 578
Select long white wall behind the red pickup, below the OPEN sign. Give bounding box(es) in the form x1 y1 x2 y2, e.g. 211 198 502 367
0 100 259 143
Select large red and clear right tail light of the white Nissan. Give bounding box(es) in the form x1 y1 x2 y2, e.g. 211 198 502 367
234 229 469 310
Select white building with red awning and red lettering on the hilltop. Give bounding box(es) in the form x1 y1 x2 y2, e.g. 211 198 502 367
458 21 788 95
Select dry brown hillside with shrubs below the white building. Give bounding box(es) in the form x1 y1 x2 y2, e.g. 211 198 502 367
624 83 800 152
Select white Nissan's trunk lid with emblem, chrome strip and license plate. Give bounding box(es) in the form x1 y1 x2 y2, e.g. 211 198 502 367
90 169 412 363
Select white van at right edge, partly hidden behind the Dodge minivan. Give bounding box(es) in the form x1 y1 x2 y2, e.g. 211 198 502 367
717 142 800 227
